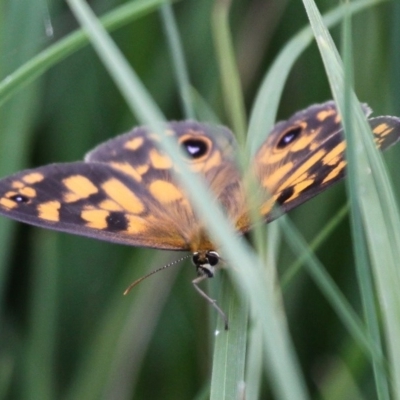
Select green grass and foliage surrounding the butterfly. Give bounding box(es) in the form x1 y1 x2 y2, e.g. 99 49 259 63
0 0 400 400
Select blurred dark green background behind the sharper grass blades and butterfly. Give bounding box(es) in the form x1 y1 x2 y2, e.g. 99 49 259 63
0 0 400 399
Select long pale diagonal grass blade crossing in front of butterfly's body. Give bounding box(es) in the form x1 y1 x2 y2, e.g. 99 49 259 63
68 0 307 399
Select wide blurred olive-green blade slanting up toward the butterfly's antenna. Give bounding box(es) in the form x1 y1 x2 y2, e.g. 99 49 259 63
65 252 179 400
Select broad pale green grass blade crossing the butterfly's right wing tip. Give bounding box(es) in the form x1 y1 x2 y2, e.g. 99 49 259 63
304 0 400 397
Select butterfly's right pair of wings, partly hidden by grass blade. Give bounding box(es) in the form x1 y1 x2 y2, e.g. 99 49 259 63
255 101 400 221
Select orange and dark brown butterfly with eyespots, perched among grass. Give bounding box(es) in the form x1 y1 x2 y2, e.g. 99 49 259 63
0 101 400 328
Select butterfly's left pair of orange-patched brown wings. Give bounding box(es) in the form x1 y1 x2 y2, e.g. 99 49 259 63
0 121 239 250
